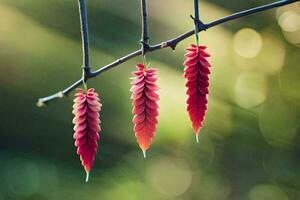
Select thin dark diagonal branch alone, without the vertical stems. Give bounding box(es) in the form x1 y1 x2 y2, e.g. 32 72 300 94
37 0 300 106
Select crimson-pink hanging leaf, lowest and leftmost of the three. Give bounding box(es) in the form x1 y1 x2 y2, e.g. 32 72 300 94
72 88 102 181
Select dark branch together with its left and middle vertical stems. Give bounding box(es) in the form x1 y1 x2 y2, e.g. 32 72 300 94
37 0 300 106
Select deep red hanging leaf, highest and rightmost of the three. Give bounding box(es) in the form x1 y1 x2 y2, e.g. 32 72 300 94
183 45 211 142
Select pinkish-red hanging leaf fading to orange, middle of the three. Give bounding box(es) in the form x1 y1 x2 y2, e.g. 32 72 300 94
130 64 159 157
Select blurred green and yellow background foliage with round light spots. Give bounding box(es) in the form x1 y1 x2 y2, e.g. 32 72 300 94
0 0 300 200
